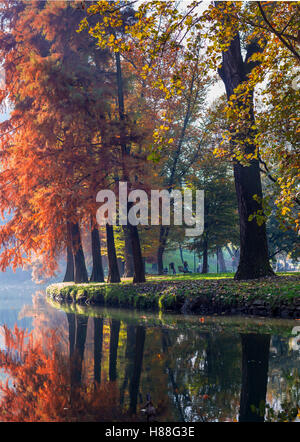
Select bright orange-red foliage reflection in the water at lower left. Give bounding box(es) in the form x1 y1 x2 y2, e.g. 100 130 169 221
0 324 122 422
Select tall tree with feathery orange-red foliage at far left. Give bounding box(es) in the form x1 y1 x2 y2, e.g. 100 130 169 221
1 1 114 282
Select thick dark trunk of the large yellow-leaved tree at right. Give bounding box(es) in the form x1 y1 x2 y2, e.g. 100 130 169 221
219 26 274 279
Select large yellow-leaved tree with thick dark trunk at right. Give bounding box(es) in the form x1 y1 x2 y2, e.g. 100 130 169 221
94 1 299 279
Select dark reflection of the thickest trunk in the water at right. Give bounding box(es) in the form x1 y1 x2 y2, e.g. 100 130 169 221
239 334 270 422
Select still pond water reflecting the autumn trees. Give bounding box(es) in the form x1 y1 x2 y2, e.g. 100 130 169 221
0 284 300 422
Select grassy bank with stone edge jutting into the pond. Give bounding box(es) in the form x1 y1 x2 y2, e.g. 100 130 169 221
47 273 300 318
